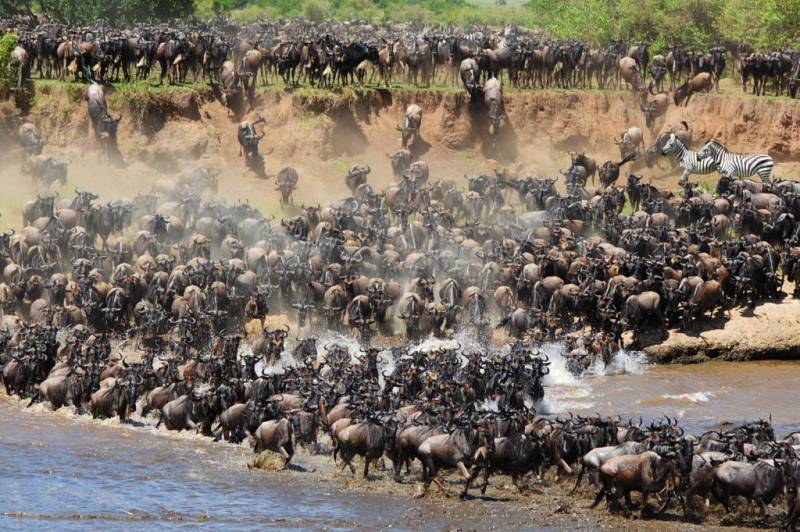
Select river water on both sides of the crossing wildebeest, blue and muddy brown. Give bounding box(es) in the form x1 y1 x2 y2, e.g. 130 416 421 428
0 351 800 530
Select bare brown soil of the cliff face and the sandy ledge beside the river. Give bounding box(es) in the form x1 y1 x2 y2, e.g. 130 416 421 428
0 85 800 361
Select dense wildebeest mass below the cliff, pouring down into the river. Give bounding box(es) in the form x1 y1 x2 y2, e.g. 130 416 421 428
0 92 800 523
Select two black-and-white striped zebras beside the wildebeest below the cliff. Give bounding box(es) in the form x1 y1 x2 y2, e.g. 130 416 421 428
661 137 775 185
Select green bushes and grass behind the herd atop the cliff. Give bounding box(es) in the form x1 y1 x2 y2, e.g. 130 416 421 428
12 0 800 53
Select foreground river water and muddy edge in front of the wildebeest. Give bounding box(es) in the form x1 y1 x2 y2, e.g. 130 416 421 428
0 386 783 531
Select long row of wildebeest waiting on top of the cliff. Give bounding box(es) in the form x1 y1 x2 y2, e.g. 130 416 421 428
0 19 800 97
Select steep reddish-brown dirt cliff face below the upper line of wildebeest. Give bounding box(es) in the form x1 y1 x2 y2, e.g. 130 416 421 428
9 86 800 214
